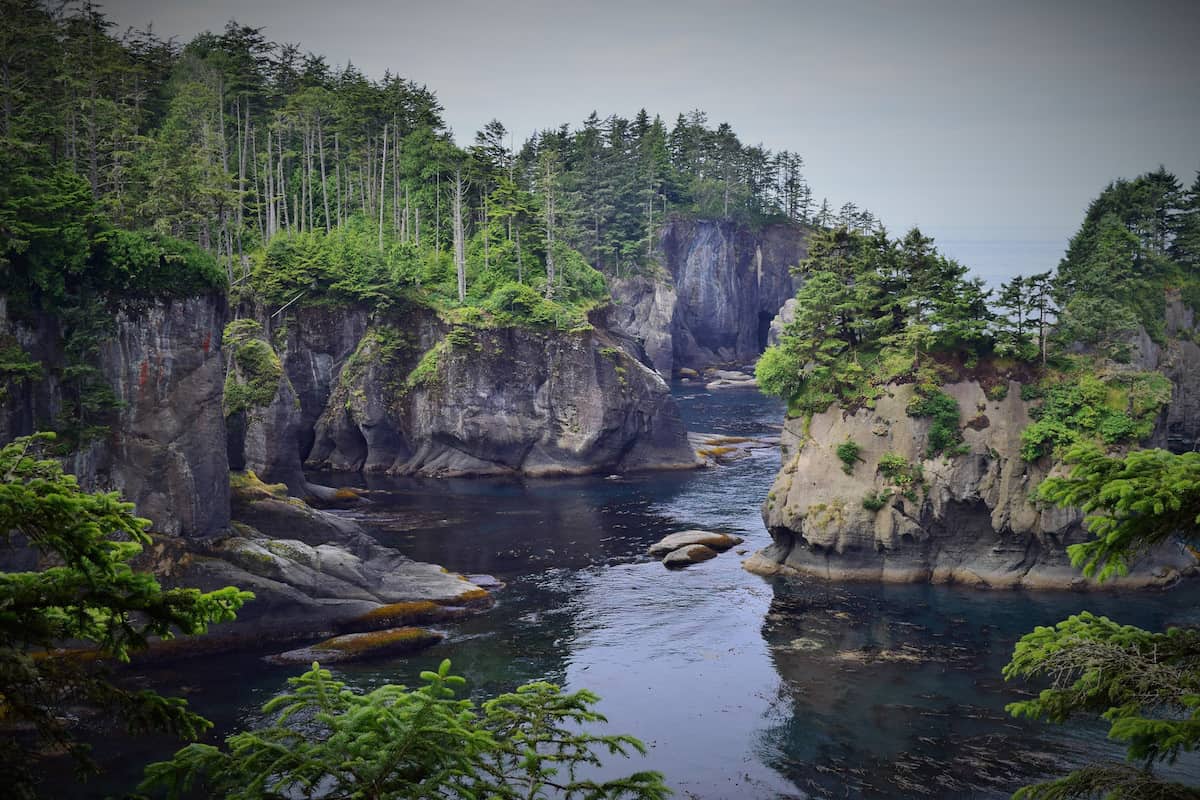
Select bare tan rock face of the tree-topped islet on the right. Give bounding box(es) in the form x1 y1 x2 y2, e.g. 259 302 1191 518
745 380 1195 588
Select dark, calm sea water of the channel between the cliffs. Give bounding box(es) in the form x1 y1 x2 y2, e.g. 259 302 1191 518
87 386 1200 798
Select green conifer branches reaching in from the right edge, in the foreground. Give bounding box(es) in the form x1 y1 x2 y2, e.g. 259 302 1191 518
1004 444 1200 800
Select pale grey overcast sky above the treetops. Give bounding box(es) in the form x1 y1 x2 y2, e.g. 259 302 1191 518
102 0 1200 283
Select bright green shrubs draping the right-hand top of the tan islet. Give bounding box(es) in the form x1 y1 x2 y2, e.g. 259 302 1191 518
1021 369 1171 461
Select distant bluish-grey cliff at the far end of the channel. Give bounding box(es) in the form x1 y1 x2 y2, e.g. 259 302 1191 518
613 219 808 375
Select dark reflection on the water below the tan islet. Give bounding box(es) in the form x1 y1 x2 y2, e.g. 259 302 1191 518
758 581 1198 798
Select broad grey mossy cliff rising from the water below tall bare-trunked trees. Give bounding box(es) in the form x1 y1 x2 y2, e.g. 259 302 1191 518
226 304 695 482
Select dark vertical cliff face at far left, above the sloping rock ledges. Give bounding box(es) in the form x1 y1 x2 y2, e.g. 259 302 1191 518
0 296 229 537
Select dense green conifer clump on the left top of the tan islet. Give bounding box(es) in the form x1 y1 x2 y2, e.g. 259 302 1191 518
756 228 992 413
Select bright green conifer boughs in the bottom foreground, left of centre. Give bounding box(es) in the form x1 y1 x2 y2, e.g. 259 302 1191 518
140 661 670 800
